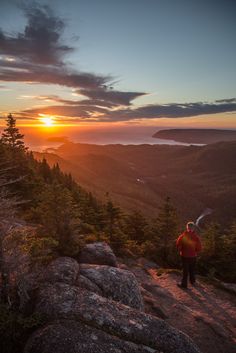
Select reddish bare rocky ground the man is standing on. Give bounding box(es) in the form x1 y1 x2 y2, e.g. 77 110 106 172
122 264 236 353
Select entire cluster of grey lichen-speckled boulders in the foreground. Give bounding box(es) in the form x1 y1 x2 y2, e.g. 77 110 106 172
21 243 200 353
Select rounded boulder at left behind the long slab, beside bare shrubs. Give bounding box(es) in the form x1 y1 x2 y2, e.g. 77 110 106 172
44 257 79 285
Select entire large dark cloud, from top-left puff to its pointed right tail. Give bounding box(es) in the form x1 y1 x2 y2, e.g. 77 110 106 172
0 4 144 107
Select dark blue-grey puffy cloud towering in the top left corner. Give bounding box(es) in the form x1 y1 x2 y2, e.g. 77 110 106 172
0 4 73 65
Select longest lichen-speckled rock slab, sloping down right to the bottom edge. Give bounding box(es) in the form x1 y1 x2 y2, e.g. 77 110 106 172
35 283 200 353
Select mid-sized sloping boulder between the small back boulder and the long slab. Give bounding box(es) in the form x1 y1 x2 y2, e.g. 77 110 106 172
80 264 144 310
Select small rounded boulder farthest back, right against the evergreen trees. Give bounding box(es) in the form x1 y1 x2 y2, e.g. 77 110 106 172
78 242 117 267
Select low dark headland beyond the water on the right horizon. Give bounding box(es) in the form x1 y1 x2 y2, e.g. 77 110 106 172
152 129 236 144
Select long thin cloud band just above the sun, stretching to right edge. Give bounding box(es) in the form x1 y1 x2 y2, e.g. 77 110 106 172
19 100 236 122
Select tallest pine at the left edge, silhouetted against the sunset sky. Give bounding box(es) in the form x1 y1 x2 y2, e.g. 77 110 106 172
1 114 26 150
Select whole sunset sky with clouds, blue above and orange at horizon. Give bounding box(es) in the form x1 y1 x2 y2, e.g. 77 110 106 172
0 0 236 144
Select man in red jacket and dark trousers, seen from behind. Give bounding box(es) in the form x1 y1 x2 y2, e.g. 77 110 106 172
176 222 202 288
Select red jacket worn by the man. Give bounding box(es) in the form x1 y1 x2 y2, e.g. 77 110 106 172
176 231 202 257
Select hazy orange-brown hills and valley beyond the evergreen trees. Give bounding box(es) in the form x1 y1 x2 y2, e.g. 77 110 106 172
36 141 236 220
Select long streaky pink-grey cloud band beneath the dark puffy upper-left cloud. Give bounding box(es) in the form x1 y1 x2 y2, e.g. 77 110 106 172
0 59 145 106
